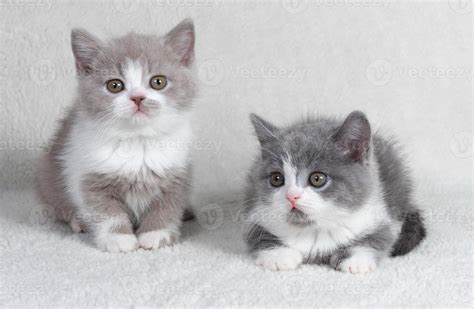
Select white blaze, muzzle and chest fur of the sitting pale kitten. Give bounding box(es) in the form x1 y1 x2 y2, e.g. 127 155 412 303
62 61 192 234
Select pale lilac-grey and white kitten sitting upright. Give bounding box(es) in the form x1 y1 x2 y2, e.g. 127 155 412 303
38 20 196 252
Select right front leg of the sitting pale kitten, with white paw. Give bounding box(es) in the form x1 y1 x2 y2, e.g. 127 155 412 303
137 172 188 249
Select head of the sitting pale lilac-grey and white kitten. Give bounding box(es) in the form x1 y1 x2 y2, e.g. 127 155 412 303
71 19 196 126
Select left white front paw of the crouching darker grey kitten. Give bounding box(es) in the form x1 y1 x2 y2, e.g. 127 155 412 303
255 248 303 270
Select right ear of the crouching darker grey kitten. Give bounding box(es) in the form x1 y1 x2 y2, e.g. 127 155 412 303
333 111 371 162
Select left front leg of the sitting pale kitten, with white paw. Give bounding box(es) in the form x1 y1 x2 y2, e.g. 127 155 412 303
80 174 138 252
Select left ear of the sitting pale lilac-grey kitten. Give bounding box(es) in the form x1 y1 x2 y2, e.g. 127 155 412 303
71 29 102 74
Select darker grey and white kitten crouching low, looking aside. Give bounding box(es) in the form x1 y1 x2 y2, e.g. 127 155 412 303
246 111 425 273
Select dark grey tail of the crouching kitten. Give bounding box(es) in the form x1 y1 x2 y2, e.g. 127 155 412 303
391 211 426 257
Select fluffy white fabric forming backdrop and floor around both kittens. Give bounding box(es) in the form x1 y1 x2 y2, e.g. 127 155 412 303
0 0 473 307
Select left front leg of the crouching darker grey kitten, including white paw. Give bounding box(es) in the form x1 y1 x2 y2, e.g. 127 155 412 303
247 225 303 270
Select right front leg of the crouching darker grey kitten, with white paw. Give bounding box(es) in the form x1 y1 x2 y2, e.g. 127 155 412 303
329 225 395 274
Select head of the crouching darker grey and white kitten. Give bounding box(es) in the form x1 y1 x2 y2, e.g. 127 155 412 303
251 112 374 226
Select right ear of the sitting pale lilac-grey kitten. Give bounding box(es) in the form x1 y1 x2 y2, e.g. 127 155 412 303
164 18 195 66
